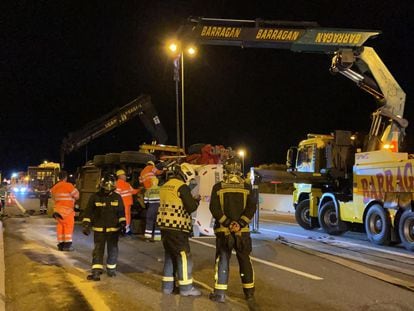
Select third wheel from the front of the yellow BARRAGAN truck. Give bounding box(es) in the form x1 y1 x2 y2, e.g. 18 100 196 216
365 204 391 245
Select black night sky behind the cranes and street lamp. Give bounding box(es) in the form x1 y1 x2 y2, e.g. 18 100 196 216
0 0 414 177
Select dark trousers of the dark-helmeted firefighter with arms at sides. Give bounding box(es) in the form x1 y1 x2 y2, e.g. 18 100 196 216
92 231 119 270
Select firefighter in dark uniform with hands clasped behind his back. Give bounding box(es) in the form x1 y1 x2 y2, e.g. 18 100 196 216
209 157 256 302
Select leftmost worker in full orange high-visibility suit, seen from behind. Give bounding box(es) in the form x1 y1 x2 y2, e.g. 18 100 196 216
50 171 79 251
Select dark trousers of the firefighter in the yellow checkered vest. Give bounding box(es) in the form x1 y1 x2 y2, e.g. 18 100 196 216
161 230 193 291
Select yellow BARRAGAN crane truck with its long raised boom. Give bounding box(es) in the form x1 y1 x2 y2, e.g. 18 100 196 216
177 18 414 250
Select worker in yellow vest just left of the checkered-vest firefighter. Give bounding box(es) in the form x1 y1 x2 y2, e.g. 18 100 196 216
144 176 161 242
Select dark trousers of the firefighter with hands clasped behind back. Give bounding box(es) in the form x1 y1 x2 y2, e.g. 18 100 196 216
214 232 254 293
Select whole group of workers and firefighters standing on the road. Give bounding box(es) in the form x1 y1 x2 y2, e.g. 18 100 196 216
50 157 256 302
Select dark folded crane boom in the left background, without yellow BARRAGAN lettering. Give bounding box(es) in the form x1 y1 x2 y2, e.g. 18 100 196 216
61 95 167 164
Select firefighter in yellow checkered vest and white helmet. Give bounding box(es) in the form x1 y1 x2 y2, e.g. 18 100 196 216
157 163 201 296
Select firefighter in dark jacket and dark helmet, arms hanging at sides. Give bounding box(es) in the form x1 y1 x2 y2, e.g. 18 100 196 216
82 175 126 281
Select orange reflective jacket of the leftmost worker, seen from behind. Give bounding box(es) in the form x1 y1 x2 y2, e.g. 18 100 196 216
50 180 79 216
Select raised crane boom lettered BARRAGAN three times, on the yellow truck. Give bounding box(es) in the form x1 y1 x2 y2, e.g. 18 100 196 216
177 18 408 151
